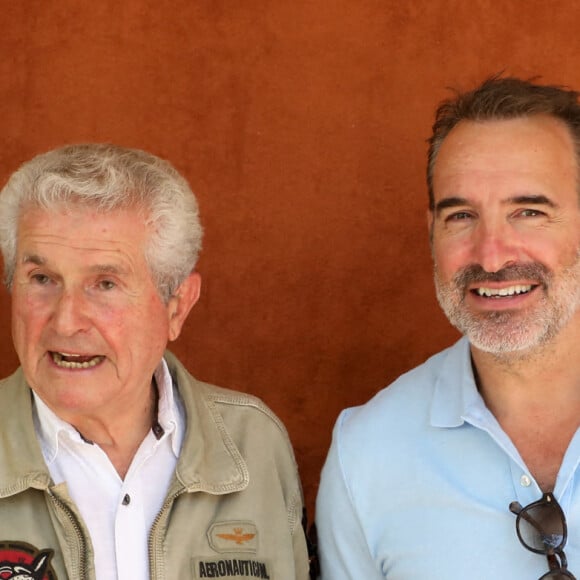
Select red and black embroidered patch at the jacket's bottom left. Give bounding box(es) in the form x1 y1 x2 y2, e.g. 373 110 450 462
0 541 57 580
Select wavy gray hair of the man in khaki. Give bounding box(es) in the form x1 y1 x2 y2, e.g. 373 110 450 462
0 144 203 301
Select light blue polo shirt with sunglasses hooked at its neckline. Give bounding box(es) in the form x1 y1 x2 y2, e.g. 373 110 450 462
316 339 580 580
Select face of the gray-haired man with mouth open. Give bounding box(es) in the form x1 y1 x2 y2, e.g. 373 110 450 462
12 208 197 422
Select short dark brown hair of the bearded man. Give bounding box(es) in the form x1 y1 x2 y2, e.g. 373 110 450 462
427 75 580 210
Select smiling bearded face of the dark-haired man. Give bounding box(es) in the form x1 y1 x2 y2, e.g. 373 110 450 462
431 116 580 353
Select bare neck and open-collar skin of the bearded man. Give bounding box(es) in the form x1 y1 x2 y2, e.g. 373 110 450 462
472 315 580 491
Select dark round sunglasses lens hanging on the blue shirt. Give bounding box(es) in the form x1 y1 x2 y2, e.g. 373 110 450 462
518 502 568 552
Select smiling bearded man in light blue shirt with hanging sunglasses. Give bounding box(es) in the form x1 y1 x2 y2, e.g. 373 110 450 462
317 77 580 580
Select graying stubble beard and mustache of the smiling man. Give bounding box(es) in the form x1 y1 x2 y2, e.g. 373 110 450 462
435 249 580 356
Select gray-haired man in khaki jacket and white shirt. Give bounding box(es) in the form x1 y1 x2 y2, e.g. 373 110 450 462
0 145 308 580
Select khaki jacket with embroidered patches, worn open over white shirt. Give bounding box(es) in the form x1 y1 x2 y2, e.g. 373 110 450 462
0 353 308 580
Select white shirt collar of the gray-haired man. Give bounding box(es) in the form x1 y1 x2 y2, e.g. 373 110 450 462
32 359 185 465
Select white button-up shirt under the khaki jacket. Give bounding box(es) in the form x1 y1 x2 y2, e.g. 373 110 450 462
34 361 185 580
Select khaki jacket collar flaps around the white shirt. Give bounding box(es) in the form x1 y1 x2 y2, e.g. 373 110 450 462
0 352 249 498
